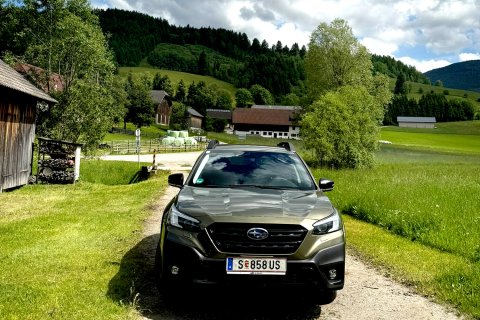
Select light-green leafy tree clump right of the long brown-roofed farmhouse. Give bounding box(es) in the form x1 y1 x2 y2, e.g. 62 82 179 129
301 19 391 168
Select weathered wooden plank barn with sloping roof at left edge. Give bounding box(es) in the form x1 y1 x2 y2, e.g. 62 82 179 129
0 60 57 192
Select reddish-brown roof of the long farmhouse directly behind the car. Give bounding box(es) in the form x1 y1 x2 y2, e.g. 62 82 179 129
232 108 297 126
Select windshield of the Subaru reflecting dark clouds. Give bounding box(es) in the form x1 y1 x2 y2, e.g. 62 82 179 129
189 151 315 190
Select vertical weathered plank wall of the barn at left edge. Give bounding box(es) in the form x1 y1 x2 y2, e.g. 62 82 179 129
0 87 37 192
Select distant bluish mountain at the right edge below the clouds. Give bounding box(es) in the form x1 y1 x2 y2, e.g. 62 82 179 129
424 60 480 92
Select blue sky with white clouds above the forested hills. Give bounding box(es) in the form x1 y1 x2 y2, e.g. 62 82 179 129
92 0 480 72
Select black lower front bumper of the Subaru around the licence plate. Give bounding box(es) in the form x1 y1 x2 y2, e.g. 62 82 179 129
162 236 345 291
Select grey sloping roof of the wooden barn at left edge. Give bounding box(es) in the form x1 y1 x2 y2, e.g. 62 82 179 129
0 60 57 103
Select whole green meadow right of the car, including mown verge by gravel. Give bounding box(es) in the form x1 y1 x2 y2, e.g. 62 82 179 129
313 122 480 318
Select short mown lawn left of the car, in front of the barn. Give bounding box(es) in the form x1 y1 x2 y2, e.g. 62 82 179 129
0 160 166 319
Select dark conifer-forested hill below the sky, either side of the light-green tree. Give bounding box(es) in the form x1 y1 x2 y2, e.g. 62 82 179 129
96 9 426 96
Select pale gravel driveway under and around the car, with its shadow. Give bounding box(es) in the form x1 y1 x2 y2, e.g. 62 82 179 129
106 153 461 320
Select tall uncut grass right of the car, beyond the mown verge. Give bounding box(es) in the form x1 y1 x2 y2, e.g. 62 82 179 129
317 164 480 262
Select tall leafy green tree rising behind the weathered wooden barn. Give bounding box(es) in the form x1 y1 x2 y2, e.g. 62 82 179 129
19 0 125 149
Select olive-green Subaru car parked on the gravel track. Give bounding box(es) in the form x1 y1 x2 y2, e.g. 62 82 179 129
156 141 345 304
